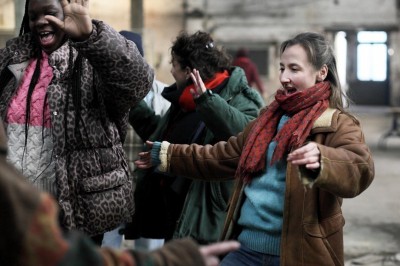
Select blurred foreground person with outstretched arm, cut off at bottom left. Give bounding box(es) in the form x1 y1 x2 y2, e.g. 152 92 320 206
0 117 239 266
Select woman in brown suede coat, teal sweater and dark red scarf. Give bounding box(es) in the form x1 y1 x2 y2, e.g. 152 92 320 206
136 33 374 266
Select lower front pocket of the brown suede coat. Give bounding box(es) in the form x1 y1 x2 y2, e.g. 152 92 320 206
303 213 345 266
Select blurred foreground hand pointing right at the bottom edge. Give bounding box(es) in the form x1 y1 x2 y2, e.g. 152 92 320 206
200 241 240 266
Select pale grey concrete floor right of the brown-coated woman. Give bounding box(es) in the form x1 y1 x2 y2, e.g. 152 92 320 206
343 107 400 266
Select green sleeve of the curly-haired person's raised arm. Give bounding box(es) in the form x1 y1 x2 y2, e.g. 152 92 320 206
196 88 262 141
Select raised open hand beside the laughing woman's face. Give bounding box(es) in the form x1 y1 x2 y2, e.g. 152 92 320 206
45 0 93 41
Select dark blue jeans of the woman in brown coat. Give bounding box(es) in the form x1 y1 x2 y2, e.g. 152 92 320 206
220 245 280 266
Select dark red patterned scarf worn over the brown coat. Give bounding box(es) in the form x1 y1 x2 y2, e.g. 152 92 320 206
237 82 331 182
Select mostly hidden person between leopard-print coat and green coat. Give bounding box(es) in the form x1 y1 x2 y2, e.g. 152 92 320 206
102 30 171 250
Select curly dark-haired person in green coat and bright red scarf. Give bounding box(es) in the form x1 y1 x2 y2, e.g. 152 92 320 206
126 31 263 244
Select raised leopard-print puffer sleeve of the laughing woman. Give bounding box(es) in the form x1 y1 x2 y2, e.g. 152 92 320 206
72 20 154 117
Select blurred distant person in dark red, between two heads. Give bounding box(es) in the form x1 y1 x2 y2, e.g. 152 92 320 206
232 47 266 95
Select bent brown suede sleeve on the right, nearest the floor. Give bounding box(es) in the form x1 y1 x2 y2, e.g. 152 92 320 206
306 114 375 198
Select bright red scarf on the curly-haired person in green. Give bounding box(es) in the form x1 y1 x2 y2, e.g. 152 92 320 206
179 70 229 111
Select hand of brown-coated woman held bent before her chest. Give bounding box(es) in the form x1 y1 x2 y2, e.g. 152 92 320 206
287 142 321 170
